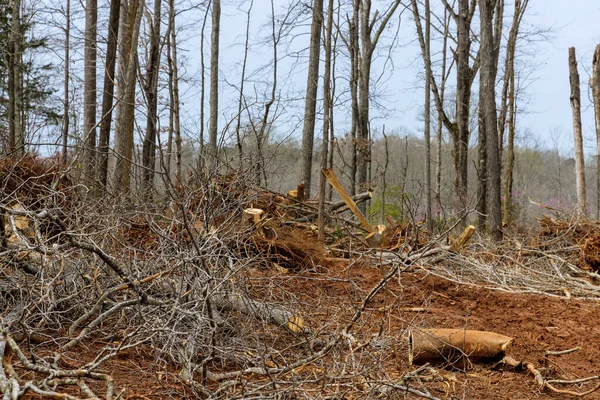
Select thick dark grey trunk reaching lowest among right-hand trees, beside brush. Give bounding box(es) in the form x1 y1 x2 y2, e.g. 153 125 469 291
479 0 502 240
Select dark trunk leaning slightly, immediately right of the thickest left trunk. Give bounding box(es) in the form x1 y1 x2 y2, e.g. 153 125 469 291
142 0 161 195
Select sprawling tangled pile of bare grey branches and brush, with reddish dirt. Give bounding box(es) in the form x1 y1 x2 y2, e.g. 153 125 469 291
0 159 600 399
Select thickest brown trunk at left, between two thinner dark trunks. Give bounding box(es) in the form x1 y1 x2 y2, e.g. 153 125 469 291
114 0 145 194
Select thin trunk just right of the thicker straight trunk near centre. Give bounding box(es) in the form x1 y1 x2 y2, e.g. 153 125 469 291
318 0 334 242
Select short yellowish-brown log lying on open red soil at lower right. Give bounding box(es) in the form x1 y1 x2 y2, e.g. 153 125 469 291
408 329 514 364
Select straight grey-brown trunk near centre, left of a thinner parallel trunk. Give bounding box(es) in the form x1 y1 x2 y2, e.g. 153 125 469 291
301 0 323 197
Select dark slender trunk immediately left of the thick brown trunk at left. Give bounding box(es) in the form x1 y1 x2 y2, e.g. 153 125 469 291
97 0 121 190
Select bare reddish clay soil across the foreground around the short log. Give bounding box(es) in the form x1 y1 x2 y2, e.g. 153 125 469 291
22 263 600 400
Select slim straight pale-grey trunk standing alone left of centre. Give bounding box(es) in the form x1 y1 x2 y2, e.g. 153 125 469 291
207 0 221 170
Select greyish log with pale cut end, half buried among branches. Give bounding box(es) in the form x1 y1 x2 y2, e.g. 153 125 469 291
211 293 306 333
